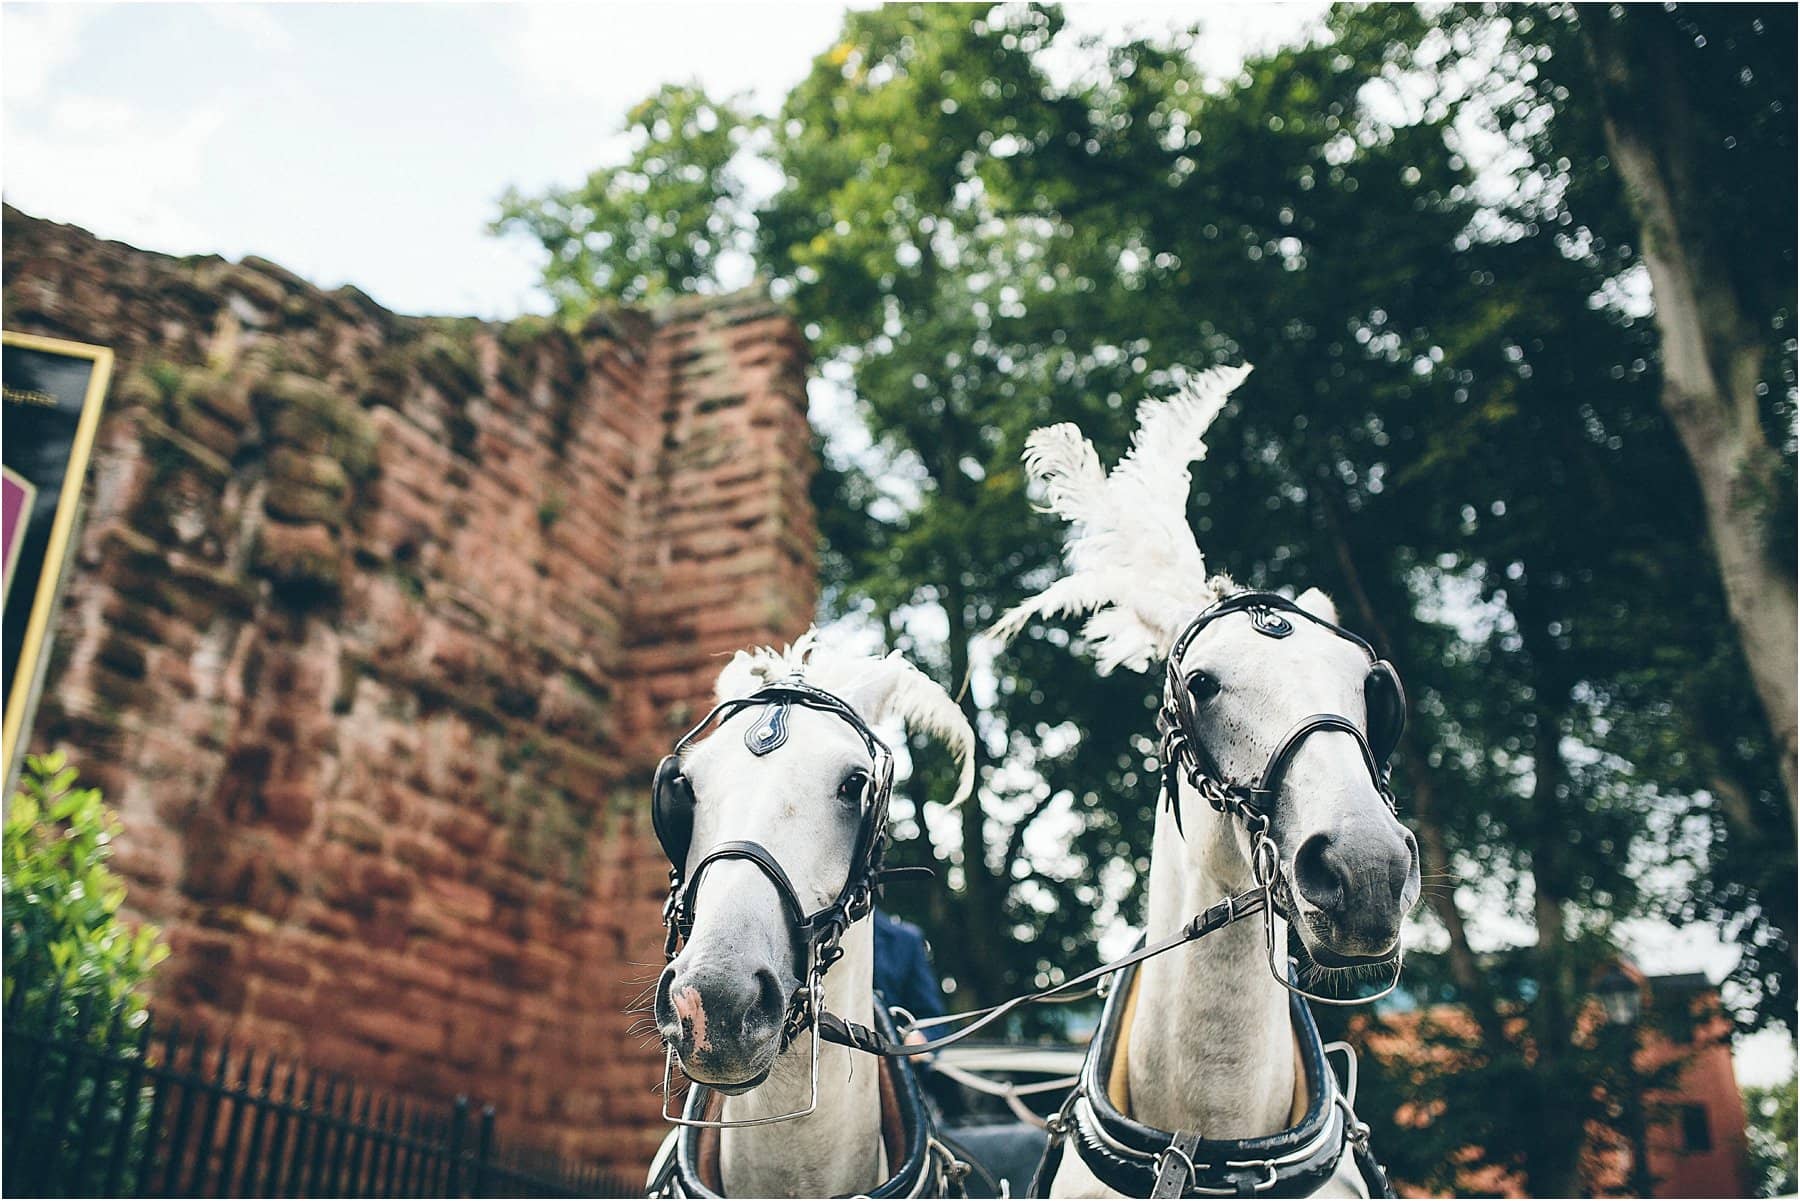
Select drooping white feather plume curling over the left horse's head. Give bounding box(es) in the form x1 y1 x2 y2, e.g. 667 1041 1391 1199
715 628 976 805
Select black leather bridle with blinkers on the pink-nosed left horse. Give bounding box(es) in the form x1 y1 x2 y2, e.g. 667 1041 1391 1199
650 677 931 1129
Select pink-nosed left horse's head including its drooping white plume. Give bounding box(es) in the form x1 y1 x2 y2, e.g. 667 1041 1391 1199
655 636 974 1093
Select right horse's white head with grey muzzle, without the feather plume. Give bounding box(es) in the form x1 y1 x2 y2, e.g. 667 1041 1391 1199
1170 591 1418 967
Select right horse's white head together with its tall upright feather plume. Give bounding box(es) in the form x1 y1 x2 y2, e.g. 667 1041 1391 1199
990 367 1418 986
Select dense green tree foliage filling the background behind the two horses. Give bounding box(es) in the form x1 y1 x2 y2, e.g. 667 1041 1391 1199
496 4 1795 1194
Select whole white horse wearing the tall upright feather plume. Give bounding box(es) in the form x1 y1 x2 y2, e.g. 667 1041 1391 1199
992 367 1420 1196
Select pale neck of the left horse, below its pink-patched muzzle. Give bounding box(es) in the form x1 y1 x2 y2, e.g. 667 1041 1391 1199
718 918 884 1197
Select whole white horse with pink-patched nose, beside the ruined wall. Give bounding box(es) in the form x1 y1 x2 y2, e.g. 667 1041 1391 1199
650 632 974 1197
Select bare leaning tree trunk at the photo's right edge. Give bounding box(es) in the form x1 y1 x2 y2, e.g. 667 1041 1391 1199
1580 9 1800 808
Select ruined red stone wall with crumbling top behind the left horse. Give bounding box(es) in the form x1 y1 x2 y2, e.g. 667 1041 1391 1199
0 207 815 1169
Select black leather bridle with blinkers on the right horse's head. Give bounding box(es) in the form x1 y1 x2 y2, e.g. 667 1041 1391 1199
1156 592 1406 1005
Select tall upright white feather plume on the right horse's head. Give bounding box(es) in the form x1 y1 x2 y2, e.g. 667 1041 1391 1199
986 366 1251 675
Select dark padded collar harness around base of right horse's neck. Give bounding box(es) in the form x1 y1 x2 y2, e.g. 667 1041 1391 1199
1030 965 1393 1197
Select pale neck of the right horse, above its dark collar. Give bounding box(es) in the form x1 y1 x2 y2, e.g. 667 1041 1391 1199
1127 785 1294 1138
